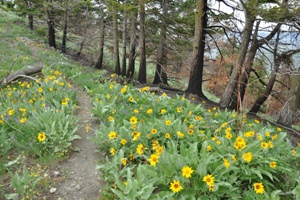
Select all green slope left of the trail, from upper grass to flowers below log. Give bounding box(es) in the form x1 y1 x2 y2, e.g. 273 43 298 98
0 9 84 199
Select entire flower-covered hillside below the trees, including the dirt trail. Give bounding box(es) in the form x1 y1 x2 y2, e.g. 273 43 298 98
0 9 300 199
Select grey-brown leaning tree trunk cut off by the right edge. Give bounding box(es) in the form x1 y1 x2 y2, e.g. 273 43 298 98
277 70 300 127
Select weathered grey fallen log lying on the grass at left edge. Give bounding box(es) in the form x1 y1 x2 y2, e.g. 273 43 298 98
0 66 43 87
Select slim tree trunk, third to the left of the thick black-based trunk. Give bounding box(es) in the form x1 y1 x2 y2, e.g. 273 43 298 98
126 7 137 79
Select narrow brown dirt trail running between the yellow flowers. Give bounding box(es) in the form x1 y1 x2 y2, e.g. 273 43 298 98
54 88 104 200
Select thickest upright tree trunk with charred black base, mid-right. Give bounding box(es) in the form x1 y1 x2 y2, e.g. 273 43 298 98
186 0 208 99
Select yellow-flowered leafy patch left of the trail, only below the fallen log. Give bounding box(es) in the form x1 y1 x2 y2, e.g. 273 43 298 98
0 68 79 199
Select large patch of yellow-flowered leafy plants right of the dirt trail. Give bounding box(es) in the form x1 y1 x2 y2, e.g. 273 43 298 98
92 75 300 199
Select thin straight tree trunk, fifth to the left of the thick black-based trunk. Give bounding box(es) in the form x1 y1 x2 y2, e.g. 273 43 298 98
112 1 121 75
